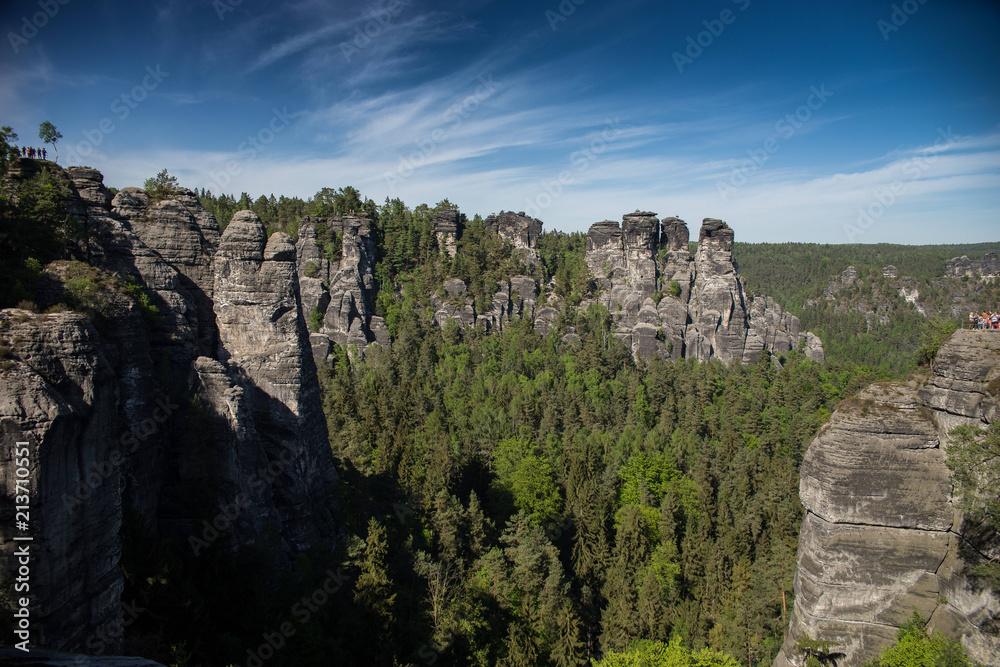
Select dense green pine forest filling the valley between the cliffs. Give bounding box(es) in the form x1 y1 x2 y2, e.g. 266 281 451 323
0 147 1000 667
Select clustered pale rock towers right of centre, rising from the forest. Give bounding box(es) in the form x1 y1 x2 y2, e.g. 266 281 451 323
584 211 824 363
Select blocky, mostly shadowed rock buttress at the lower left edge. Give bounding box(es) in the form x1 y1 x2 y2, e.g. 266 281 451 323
0 310 124 648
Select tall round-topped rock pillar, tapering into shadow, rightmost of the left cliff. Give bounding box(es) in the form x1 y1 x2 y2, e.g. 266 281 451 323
214 211 337 551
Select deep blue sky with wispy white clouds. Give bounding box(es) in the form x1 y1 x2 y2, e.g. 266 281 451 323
0 0 1000 243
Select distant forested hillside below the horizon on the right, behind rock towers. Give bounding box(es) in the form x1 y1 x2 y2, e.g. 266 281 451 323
733 242 1000 377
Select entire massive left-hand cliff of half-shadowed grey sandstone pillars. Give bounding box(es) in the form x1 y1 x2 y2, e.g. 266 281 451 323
0 168 337 652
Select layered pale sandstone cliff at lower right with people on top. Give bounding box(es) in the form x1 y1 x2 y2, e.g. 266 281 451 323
774 331 1000 667
